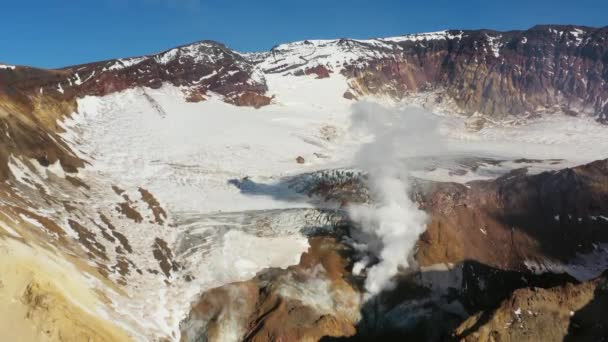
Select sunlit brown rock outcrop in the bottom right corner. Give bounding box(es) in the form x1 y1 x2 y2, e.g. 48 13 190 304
456 277 608 341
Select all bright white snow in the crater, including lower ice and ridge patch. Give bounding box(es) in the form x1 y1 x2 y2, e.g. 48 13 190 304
58 69 608 340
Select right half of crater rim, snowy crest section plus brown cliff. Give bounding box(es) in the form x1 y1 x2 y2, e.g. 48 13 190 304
260 26 608 120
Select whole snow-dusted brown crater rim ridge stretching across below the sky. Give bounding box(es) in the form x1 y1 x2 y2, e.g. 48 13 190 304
0 25 608 120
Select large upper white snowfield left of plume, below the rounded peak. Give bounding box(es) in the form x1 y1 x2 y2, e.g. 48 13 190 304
73 78 347 211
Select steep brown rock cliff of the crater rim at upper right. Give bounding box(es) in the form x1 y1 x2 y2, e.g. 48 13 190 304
344 26 608 120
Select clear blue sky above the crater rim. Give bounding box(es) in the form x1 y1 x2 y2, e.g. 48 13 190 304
0 0 608 67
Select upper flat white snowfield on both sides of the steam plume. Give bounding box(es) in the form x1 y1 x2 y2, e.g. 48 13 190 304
66 70 608 238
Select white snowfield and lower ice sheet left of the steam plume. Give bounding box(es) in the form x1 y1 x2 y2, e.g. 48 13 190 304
61 76 356 340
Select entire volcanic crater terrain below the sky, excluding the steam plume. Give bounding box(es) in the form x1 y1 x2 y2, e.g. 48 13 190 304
0 26 608 341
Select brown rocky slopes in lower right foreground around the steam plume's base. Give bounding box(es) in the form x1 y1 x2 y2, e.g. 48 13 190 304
182 160 608 341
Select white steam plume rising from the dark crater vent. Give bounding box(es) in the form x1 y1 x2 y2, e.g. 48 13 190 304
348 102 441 295
